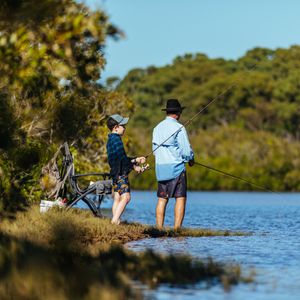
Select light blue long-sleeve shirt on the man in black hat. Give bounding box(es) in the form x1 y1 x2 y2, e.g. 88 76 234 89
152 117 194 181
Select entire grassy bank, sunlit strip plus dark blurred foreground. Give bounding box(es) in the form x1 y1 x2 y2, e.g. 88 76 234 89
0 207 253 299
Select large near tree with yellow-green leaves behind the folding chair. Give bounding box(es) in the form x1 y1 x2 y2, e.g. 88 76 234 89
0 0 132 210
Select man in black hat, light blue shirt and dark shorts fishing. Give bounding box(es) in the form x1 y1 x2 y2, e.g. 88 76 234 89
152 99 194 229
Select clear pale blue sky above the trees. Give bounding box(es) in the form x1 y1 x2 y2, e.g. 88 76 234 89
84 0 300 80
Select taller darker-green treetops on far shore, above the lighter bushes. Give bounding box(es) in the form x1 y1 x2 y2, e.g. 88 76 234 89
118 46 300 139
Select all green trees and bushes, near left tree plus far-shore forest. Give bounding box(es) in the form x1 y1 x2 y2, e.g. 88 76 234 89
0 0 300 216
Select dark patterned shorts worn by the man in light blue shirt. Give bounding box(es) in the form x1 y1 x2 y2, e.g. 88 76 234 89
157 171 187 199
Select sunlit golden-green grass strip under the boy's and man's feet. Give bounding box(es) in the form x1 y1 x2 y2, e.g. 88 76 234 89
0 206 247 253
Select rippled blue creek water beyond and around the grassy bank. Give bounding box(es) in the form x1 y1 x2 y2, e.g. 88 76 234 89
95 191 300 300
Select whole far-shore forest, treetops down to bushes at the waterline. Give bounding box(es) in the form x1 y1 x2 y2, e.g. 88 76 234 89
116 46 300 191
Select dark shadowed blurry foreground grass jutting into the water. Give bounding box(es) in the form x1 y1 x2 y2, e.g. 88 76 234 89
0 226 253 299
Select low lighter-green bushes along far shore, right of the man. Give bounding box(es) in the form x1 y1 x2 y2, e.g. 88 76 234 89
188 127 300 191
